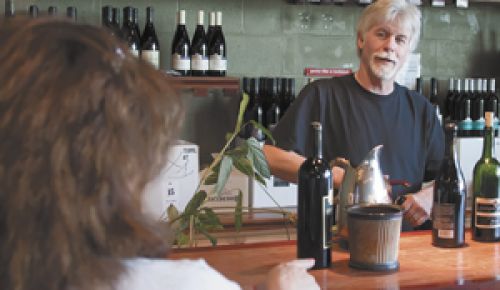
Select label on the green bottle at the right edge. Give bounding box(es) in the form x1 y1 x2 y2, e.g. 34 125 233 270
474 197 500 229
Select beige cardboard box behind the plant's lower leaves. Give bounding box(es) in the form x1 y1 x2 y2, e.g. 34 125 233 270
200 168 249 212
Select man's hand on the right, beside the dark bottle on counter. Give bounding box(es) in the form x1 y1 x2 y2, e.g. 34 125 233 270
401 182 434 227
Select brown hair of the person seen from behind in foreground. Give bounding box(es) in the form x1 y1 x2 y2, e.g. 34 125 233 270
0 17 183 290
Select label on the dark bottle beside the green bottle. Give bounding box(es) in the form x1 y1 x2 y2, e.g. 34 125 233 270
432 203 455 239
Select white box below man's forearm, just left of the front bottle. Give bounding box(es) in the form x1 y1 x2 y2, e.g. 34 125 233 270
250 176 297 208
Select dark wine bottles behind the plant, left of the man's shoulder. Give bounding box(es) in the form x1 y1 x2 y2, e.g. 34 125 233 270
240 77 295 142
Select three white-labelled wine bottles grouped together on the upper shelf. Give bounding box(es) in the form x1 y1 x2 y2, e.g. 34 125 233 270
172 10 227 76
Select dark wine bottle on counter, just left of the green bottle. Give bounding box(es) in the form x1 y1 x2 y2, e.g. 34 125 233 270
432 123 466 248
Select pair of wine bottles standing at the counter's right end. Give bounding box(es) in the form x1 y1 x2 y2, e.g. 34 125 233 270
432 111 500 247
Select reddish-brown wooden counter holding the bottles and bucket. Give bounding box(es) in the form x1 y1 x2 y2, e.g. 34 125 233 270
170 231 500 289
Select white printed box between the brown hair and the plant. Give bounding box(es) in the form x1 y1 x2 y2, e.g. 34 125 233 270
142 140 200 220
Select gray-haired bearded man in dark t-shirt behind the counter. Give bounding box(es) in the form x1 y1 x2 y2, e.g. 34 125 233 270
264 0 444 230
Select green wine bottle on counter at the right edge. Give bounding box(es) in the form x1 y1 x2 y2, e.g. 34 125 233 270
471 112 500 242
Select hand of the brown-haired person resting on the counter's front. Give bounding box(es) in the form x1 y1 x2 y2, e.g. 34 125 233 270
266 259 320 290
